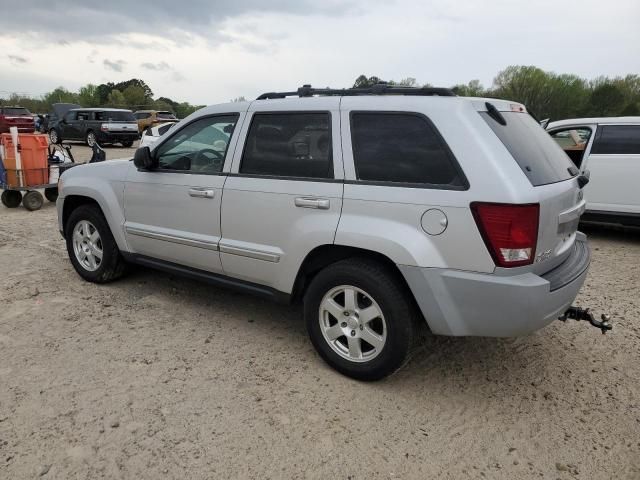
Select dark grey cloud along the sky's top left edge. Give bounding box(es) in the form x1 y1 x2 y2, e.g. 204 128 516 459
0 0 364 45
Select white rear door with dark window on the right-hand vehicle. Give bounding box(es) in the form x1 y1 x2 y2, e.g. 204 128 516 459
585 124 640 213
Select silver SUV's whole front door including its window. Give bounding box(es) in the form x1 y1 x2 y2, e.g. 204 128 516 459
124 113 240 273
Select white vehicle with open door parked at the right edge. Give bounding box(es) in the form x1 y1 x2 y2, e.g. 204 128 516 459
547 117 640 226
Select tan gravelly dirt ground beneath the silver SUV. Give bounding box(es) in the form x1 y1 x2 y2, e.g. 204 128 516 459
0 147 640 480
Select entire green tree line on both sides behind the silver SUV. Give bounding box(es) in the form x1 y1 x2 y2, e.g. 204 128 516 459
0 65 640 120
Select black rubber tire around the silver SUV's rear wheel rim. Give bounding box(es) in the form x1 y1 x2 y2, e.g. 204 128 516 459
304 258 416 381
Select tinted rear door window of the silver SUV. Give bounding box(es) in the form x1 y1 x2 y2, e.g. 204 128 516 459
240 113 333 178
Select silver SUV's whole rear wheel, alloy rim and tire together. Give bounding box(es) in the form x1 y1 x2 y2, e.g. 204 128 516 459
304 258 416 380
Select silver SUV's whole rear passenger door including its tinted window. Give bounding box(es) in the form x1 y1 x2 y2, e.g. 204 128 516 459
220 98 343 292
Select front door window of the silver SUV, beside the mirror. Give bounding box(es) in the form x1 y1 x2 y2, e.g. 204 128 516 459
155 114 238 174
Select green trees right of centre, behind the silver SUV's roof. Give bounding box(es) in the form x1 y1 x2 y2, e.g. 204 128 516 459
353 65 640 120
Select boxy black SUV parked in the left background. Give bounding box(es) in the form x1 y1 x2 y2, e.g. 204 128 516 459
49 104 138 147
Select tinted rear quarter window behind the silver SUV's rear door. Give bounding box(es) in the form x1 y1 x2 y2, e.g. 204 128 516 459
351 113 466 188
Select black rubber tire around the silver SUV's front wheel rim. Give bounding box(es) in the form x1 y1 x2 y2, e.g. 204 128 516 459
64 205 127 283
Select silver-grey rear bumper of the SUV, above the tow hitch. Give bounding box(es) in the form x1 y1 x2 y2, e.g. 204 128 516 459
399 233 590 337
